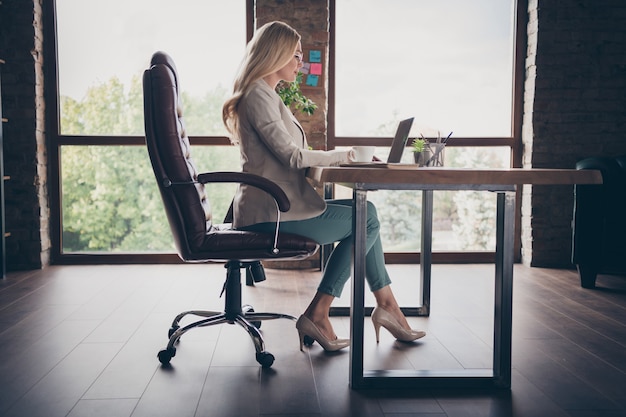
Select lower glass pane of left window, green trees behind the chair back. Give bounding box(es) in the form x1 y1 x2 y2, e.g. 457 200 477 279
61 146 239 253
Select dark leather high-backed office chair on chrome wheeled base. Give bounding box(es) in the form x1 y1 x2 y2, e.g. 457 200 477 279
143 52 318 367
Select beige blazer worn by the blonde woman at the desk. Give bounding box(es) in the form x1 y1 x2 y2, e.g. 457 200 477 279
233 80 348 227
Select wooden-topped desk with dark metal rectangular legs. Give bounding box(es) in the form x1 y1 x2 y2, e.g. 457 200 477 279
308 165 602 389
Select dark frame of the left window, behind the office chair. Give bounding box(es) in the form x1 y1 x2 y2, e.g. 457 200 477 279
43 0 255 265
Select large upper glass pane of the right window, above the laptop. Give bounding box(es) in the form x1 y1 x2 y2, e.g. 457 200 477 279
335 0 515 137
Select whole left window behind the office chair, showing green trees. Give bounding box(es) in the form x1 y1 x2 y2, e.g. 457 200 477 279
47 0 252 257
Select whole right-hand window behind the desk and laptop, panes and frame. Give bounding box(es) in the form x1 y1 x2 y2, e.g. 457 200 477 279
329 0 521 259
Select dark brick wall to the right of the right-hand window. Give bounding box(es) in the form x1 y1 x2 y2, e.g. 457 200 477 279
522 0 626 267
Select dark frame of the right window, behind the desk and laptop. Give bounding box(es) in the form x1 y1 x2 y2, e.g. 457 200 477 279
327 0 528 263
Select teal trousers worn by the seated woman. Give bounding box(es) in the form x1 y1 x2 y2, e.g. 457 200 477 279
241 200 391 297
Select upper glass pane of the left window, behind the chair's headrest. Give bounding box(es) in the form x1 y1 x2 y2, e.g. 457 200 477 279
56 0 246 136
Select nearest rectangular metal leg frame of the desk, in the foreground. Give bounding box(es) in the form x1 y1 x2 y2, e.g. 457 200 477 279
349 186 515 389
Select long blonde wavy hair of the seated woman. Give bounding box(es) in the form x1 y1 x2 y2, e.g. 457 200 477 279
222 21 301 144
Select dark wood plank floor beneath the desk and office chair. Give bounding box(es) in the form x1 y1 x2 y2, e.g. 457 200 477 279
0 265 626 417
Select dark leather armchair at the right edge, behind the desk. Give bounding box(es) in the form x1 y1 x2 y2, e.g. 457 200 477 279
572 155 626 288
